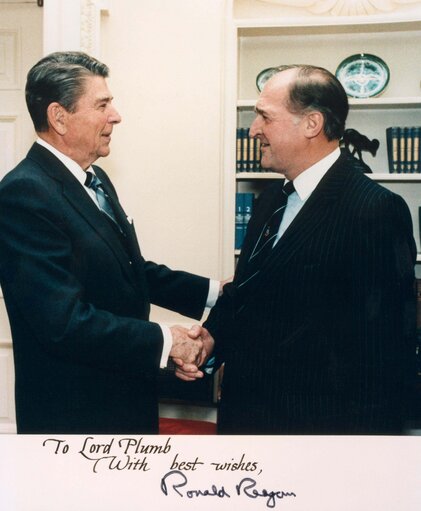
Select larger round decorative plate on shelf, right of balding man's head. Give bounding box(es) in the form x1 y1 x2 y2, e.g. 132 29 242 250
336 53 390 98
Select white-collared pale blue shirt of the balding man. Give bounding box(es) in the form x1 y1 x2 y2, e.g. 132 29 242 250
274 147 341 245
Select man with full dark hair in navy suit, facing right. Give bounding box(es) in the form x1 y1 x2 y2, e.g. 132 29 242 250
0 52 219 433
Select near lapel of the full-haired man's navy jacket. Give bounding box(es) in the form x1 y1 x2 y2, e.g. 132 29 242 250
28 144 138 286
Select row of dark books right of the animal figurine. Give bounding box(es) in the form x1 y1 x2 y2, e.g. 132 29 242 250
386 126 421 173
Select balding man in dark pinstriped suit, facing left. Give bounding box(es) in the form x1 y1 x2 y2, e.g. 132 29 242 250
179 62 416 434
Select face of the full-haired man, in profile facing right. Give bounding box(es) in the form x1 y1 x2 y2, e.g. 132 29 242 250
65 76 121 169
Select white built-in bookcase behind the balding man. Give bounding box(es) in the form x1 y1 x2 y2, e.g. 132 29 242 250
226 14 421 272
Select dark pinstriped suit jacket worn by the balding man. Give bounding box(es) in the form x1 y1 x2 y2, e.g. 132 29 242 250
206 156 415 434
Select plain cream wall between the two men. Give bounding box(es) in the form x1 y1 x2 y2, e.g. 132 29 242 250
99 0 225 321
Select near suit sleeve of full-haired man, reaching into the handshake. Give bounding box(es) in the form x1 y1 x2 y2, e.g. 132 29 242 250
0 179 163 374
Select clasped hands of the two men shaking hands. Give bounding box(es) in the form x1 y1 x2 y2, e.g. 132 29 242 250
170 325 215 381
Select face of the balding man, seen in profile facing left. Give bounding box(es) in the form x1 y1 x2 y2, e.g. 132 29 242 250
250 70 306 179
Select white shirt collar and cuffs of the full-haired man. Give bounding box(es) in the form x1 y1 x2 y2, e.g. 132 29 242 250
37 138 220 368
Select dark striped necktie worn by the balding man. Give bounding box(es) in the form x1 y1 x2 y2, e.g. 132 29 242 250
238 181 295 288
